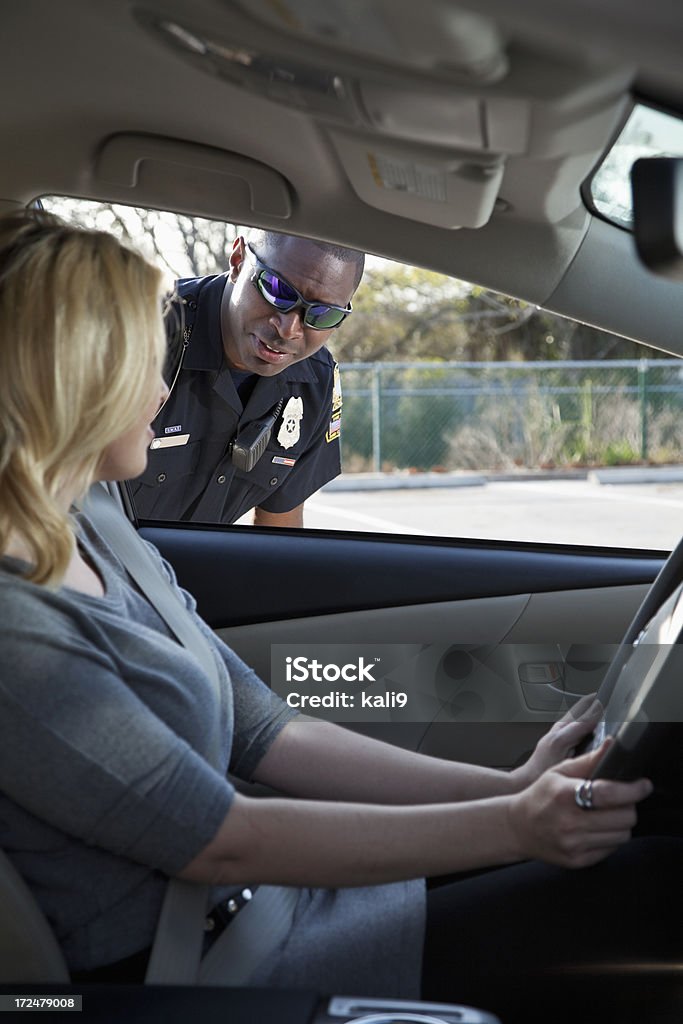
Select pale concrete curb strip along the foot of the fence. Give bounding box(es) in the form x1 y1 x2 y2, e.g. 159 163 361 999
321 466 683 494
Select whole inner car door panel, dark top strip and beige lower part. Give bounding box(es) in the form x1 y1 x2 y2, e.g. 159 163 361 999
142 526 660 768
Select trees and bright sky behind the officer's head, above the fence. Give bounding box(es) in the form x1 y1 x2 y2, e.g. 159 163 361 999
38 197 663 361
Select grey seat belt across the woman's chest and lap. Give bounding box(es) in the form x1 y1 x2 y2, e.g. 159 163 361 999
80 483 299 985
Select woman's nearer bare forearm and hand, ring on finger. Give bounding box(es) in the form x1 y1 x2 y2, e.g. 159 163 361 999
180 746 651 887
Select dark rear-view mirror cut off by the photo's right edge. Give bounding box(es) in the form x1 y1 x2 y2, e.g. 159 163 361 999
631 157 683 281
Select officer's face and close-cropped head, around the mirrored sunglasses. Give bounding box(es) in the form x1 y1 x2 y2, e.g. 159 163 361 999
221 238 356 377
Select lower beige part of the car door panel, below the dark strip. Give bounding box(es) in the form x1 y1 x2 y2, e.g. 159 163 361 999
217 585 647 768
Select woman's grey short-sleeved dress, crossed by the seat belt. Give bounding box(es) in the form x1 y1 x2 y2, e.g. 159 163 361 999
0 516 424 997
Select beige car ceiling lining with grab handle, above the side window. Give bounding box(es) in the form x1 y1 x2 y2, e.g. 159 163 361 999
0 0 683 353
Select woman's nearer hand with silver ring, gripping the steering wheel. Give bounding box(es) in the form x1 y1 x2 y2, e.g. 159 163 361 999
509 741 652 867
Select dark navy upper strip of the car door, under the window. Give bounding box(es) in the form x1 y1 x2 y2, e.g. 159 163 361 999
140 522 664 629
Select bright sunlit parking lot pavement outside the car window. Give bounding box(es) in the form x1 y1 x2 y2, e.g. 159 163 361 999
304 479 683 551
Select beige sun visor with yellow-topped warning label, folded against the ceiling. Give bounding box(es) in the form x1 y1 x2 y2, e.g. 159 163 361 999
330 130 504 227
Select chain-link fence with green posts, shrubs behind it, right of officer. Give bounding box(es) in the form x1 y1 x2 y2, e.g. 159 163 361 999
341 359 683 472
